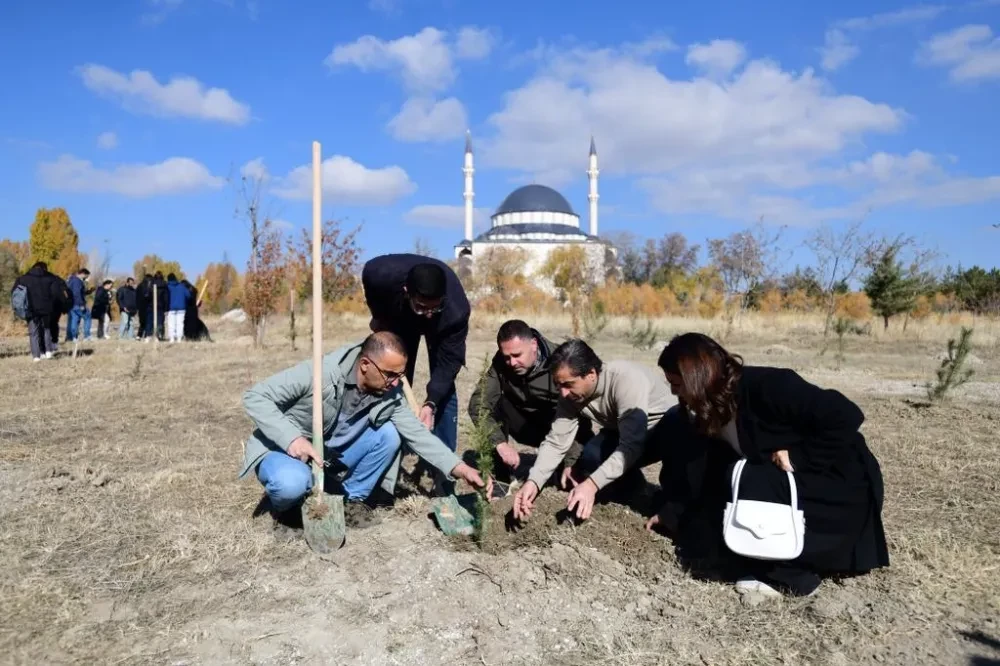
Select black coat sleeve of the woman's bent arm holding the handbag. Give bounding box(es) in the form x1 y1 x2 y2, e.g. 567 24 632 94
754 369 865 473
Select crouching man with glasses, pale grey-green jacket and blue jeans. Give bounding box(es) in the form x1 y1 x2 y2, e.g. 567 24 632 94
240 331 483 532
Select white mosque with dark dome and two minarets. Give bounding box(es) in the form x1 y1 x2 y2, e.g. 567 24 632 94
455 135 614 291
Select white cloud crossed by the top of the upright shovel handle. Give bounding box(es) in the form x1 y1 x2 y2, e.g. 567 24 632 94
261 155 417 205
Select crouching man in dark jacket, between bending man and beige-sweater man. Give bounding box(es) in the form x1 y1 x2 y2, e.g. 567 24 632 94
469 319 591 478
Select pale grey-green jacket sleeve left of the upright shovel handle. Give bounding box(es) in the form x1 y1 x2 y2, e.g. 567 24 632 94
243 360 312 451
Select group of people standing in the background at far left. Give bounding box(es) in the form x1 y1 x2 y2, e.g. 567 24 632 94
12 262 210 362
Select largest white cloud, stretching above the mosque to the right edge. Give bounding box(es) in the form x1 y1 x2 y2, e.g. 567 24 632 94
477 40 998 224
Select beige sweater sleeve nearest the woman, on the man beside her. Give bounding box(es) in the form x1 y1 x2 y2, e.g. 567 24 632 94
590 374 652 489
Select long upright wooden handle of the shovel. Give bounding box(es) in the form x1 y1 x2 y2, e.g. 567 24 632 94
312 141 326 498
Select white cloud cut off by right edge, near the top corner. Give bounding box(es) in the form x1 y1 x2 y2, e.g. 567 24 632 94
917 25 1000 82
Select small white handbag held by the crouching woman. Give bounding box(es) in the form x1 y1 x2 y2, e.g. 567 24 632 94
722 458 806 560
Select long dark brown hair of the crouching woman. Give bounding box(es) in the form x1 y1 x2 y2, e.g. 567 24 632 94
657 333 743 436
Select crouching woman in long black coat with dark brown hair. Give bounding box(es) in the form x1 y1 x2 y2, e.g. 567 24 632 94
647 333 889 595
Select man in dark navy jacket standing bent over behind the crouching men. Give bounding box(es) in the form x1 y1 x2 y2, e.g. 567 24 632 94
361 254 470 466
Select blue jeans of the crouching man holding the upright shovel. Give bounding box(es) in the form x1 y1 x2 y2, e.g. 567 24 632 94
257 423 399 512
